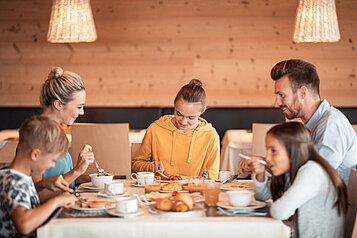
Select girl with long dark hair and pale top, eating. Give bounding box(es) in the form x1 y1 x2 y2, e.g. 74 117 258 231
250 122 348 238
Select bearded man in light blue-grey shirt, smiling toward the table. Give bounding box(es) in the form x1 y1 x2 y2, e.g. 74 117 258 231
238 59 357 186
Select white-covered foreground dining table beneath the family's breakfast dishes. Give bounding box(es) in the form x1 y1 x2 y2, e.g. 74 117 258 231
37 180 290 238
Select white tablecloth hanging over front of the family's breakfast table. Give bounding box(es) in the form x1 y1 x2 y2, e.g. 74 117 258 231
37 180 290 238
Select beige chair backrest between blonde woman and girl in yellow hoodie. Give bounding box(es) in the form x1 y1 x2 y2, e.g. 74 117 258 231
71 123 131 177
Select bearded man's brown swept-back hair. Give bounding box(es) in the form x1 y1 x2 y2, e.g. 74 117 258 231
270 59 320 96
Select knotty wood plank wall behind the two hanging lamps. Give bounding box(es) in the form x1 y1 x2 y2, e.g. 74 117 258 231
0 0 357 107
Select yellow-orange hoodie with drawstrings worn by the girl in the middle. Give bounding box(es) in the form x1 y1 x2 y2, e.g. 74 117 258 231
131 115 220 179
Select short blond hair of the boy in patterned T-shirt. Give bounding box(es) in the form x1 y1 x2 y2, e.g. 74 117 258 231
17 116 69 157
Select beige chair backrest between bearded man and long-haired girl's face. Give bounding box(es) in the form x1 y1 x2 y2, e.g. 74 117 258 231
252 123 276 157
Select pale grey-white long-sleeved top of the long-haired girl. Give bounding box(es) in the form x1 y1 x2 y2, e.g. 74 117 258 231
254 161 344 238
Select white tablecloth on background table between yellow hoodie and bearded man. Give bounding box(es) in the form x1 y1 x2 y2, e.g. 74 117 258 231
220 130 253 173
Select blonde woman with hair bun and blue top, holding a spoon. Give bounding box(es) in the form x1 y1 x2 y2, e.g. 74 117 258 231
34 67 94 200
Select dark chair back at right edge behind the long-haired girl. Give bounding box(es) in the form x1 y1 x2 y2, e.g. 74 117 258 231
344 169 357 238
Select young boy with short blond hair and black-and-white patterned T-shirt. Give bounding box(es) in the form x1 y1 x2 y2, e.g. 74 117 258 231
0 116 76 237
